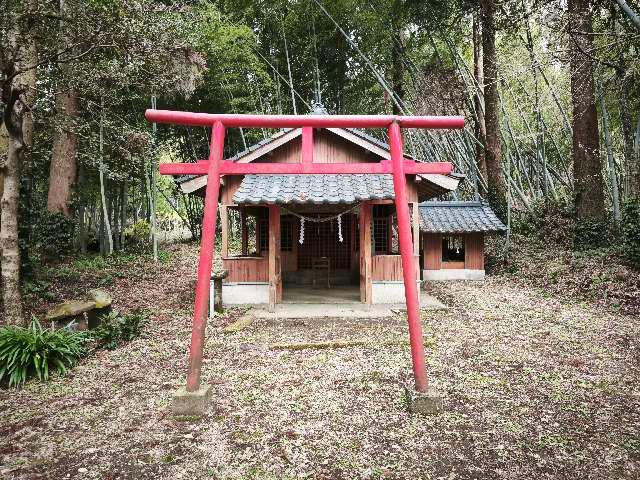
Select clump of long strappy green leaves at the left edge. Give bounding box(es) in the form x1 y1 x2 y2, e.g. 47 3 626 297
0 318 87 386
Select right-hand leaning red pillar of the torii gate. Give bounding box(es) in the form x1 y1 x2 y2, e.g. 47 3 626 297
388 122 428 392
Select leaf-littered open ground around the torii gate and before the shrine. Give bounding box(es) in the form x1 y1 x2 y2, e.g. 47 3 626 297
0 245 640 480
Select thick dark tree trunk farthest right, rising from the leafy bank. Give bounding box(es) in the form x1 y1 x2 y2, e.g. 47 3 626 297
568 0 606 220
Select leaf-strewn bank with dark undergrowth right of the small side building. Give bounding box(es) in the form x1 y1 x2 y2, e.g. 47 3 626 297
487 202 640 315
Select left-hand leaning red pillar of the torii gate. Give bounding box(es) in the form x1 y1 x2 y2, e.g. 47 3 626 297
187 122 225 392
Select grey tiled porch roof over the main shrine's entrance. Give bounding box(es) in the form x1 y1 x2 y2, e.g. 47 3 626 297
233 174 394 205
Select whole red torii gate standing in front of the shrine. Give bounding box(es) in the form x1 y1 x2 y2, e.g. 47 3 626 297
145 109 464 404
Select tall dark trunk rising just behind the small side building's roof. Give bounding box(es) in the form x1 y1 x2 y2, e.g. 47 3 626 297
480 0 507 219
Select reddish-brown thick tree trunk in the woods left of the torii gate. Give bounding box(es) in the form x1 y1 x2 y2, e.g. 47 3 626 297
47 89 78 217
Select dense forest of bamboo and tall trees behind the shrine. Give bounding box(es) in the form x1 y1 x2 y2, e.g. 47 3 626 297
0 0 640 323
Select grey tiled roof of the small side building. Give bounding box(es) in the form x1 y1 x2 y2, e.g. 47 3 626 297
420 202 507 233
